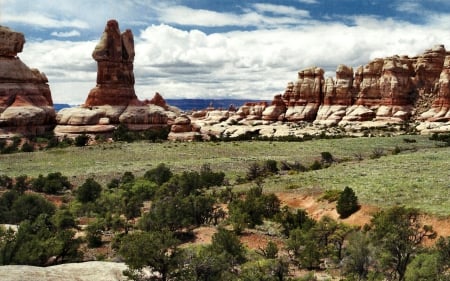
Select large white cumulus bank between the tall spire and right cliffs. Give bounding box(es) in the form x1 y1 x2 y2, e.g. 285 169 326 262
128 17 450 99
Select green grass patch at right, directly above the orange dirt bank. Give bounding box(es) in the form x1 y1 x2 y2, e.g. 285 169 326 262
264 148 450 216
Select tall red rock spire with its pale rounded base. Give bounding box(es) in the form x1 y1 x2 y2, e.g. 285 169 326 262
55 20 176 135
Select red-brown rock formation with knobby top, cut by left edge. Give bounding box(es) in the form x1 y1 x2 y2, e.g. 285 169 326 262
0 26 55 136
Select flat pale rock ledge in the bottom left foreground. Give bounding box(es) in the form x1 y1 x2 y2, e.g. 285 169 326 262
0 261 127 281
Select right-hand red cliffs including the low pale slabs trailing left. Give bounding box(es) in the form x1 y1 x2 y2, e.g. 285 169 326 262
191 45 450 137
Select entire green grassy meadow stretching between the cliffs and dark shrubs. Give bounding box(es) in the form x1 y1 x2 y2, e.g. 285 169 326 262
0 133 450 216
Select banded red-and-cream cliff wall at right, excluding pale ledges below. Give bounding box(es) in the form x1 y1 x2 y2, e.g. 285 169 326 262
262 45 450 125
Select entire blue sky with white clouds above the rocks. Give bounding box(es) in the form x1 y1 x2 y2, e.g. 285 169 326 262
0 0 450 105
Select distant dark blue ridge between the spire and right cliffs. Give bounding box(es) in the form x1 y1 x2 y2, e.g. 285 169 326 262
166 99 270 111
